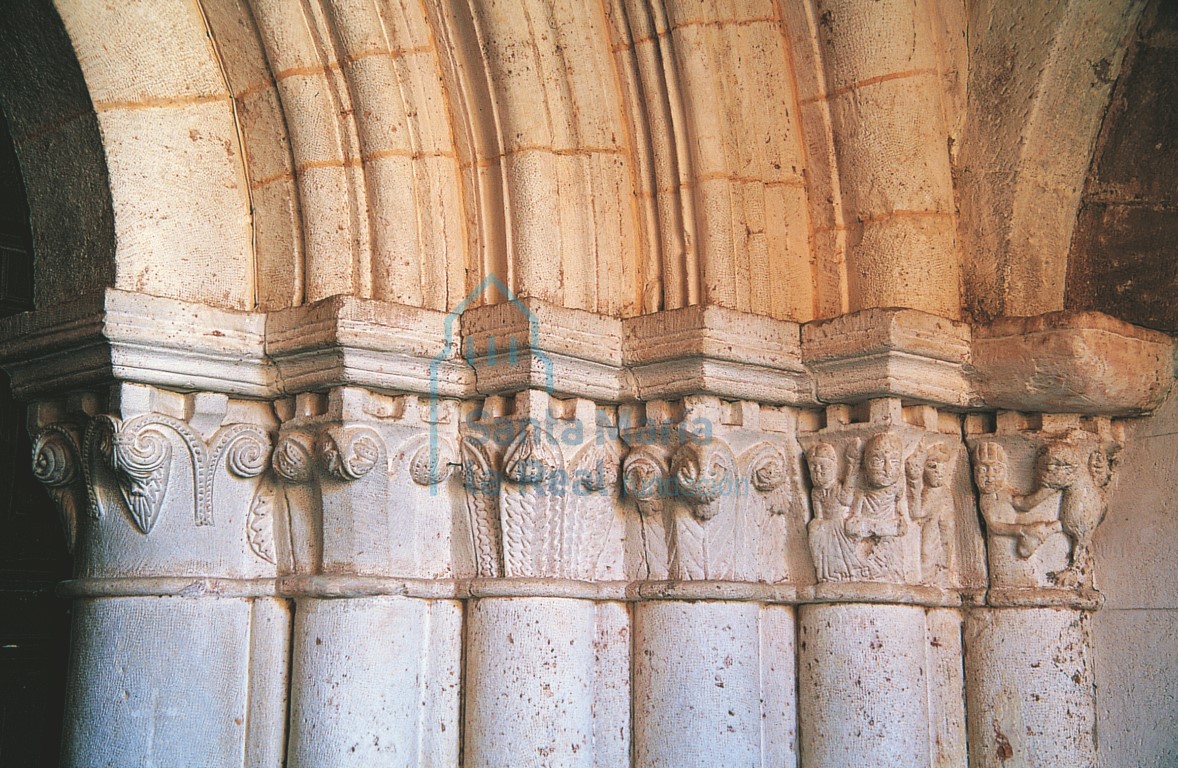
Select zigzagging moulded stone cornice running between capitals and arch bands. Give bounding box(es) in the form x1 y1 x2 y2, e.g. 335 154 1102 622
0 289 1173 416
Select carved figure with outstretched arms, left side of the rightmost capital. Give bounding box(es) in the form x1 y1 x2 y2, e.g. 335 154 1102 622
973 443 1064 560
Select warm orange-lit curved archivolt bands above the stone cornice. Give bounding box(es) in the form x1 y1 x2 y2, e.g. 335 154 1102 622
6 0 1140 320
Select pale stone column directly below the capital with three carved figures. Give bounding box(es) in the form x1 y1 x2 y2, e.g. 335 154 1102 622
798 603 933 768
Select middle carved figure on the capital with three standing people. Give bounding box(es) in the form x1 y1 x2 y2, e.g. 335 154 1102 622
845 432 908 583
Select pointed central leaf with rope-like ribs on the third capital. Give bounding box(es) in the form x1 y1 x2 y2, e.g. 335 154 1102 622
499 423 567 576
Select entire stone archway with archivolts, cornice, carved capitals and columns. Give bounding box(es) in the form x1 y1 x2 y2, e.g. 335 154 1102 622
0 0 1173 767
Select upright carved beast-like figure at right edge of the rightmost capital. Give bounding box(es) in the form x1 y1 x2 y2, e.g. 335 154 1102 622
1043 442 1112 589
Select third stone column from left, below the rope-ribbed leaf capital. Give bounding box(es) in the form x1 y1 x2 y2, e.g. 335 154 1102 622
465 597 596 768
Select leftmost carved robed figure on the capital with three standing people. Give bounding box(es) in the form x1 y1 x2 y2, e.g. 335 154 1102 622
806 443 863 582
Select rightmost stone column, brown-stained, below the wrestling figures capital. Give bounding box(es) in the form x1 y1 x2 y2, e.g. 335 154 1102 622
965 608 1097 768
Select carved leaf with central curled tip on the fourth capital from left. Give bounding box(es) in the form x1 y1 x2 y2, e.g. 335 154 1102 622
671 439 739 578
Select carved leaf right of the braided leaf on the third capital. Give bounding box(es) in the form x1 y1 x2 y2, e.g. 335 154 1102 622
564 443 618 580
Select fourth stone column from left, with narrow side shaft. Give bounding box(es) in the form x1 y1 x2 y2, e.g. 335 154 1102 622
633 601 796 768
